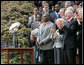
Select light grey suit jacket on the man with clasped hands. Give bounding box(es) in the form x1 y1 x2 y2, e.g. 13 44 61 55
37 22 55 50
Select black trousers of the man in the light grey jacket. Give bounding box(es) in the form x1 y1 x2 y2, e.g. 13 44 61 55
40 50 54 64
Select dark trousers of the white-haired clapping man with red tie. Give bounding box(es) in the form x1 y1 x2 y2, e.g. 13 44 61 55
64 48 76 64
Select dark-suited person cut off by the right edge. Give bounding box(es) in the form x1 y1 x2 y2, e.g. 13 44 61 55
76 8 83 64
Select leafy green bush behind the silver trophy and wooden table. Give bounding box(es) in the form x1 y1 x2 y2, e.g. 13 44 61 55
1 1 35 64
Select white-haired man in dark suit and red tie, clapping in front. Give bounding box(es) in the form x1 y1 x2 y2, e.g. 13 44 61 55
59 10 78 64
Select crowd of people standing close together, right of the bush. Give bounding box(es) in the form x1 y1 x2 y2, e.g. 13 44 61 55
28 1 83 64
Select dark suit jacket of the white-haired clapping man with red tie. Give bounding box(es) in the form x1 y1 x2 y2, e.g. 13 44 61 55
59 18 78 48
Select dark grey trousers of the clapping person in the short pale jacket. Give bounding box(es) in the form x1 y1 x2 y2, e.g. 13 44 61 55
54 47 64 64
